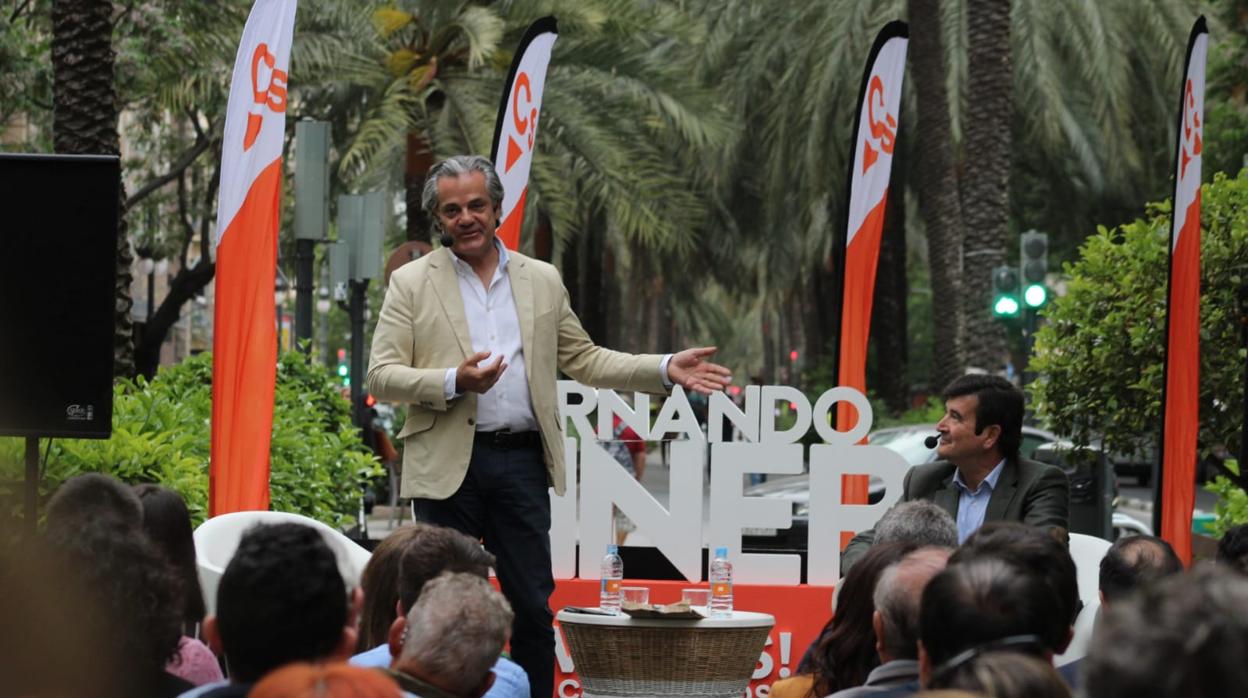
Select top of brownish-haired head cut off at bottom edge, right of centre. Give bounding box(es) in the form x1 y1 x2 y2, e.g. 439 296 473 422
929 651 1071 698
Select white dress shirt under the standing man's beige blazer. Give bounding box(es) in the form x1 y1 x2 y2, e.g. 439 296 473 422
443 243 671 432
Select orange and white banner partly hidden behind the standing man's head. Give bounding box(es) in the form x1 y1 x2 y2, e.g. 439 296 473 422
492 17 559 250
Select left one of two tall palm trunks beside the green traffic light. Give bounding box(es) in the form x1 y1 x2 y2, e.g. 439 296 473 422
907 0 966 391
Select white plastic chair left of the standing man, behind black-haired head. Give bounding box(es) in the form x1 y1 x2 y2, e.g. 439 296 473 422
195 512 372 613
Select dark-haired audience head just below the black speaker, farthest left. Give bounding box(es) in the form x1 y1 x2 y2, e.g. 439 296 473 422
47 472 144 534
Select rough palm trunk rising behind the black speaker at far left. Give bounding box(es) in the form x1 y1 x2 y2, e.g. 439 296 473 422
52 0 135 376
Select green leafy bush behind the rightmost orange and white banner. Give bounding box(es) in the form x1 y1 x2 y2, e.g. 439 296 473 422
1030 171 1248 524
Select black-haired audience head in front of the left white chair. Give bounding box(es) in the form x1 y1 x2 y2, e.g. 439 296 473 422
203 523 356 683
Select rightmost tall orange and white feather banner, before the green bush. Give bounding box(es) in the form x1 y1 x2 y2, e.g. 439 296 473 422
1156 16 1209 562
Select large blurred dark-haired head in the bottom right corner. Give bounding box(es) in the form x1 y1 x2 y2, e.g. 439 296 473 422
1082 566 1248 698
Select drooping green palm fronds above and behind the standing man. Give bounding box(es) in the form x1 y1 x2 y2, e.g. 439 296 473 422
341 0 730 354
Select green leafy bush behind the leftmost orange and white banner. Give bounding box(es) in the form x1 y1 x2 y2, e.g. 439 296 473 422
0 351 383 526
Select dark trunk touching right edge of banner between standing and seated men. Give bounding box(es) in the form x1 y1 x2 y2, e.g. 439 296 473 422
867 145 910 413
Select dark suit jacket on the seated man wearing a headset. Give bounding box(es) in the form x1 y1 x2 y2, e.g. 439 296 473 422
841 458 1071 574
